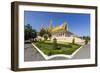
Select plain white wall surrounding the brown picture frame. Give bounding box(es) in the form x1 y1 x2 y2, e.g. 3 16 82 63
0 0 100 73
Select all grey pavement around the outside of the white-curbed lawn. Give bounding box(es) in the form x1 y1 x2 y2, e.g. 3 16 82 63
24 44 90 61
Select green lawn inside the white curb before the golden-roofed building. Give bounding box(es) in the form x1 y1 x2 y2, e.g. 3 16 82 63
34 41 81 55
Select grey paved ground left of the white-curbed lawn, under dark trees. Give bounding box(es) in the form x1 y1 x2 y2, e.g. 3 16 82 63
24 44 45 61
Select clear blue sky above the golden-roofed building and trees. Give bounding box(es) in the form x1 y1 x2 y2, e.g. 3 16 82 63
24 11 90 36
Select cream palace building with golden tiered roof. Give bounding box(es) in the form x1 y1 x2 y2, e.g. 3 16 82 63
48 22 84 43
